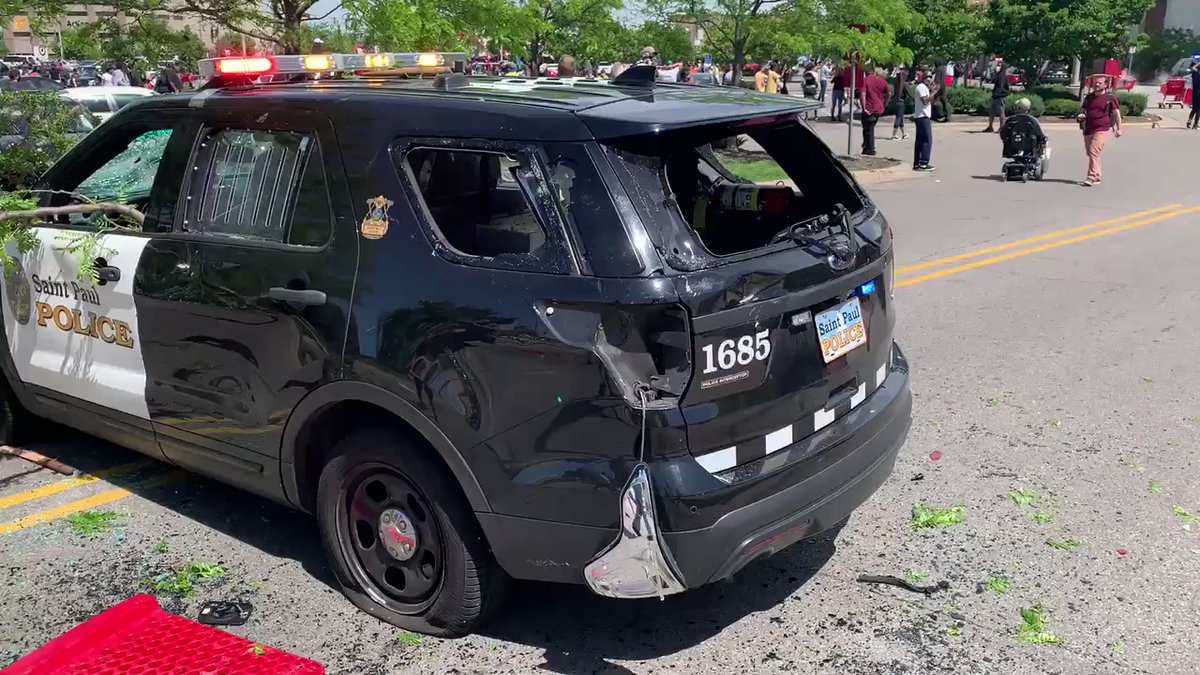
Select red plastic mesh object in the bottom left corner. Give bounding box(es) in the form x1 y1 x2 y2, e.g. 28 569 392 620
0 596 325 675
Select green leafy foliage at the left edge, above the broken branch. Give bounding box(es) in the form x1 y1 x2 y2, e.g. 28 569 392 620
0 91 91 190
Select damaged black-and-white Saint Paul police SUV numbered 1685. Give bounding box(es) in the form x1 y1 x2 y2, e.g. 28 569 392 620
2 49 912 635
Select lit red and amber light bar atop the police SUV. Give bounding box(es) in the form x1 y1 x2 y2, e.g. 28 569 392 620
198 52 468 89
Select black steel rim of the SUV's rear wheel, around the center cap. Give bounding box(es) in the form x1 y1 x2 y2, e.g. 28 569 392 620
337 462 445 614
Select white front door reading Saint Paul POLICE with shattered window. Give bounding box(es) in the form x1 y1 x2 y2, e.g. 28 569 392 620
2 110 192 455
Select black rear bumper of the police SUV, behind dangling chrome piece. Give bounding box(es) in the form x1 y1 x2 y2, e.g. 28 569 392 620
476 347 912 588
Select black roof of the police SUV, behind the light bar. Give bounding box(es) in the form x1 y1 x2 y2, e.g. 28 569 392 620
166 76 820 141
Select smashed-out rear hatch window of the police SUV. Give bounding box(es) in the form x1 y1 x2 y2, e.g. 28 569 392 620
606 117 865 269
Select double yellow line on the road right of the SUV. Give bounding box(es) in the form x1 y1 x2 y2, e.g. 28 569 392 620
895 204 1200 288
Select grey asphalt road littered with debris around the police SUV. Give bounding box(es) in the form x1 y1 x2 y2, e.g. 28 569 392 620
0 105 1200 675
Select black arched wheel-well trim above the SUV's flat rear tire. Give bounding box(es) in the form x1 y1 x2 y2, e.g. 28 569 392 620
280 380 492 513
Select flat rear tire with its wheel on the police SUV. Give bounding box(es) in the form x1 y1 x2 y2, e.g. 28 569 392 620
317 428 509 638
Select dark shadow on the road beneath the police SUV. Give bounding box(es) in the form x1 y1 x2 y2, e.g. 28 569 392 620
24 425 841 674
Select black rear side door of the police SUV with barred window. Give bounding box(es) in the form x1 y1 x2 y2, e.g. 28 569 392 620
134 101 358 494
